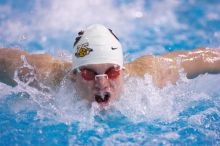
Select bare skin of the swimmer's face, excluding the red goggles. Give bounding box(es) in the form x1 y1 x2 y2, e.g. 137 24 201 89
71 64 123 105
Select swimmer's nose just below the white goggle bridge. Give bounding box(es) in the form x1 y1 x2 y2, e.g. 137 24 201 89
95 75 109 90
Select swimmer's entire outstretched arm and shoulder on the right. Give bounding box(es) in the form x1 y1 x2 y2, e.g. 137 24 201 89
125 49 220 88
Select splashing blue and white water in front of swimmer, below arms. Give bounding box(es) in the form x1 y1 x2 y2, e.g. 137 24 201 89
0 71 220 145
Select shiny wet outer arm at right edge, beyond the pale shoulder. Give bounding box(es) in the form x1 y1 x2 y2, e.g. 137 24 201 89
162 48 220 79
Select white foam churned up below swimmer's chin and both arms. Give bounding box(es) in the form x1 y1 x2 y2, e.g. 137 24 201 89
0 71 220 129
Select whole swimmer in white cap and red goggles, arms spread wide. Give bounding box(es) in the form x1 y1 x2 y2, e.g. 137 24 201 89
0 24 220 106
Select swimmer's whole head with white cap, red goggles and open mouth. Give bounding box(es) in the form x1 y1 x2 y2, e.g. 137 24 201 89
71 24 123 105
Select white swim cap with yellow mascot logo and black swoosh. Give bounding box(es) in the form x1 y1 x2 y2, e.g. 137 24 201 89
72 24 123 69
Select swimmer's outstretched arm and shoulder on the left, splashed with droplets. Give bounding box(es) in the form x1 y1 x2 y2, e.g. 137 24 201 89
0 48 71 88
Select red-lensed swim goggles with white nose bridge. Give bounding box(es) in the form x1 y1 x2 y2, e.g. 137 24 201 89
77 65 121 81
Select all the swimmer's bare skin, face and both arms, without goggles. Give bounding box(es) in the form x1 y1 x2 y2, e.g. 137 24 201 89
0 48 220 105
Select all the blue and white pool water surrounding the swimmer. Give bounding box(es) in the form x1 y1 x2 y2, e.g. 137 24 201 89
0 0 220 146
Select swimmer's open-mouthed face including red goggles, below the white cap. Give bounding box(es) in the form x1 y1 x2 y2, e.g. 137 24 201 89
74 64 123 105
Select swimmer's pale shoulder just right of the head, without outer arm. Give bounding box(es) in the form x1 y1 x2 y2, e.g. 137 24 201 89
125 55 178 87
